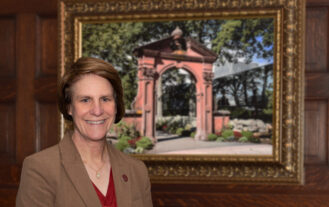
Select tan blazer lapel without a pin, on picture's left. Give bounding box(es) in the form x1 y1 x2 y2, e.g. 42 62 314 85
59 133 102 207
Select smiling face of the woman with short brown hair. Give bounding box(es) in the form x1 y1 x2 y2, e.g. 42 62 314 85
68 74 116 141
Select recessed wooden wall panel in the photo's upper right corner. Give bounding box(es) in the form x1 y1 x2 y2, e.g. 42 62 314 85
305 7 328 72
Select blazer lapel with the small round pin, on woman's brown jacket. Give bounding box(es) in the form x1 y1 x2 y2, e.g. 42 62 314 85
108 145 132 207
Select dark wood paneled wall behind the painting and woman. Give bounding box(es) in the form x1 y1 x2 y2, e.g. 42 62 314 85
0 0 329 207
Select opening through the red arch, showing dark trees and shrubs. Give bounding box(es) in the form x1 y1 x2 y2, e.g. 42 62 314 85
155 68 196 141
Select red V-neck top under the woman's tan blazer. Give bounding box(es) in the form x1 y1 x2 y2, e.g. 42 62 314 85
93 169 117 207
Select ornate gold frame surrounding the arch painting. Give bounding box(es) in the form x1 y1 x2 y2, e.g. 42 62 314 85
58 0 305 184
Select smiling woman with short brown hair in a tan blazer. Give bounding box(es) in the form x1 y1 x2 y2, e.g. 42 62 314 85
16 58 152 207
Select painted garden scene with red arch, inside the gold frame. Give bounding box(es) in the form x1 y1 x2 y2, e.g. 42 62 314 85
81 17 275 155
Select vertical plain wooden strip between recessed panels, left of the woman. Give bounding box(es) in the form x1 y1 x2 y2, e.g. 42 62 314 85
16 13 36 163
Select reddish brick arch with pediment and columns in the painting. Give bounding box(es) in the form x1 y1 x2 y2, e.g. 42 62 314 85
132 37 217 142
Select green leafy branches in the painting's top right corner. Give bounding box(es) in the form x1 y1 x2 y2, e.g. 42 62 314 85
212 18 274 63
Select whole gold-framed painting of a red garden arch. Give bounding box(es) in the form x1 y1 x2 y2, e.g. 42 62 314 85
59 0 305 184
